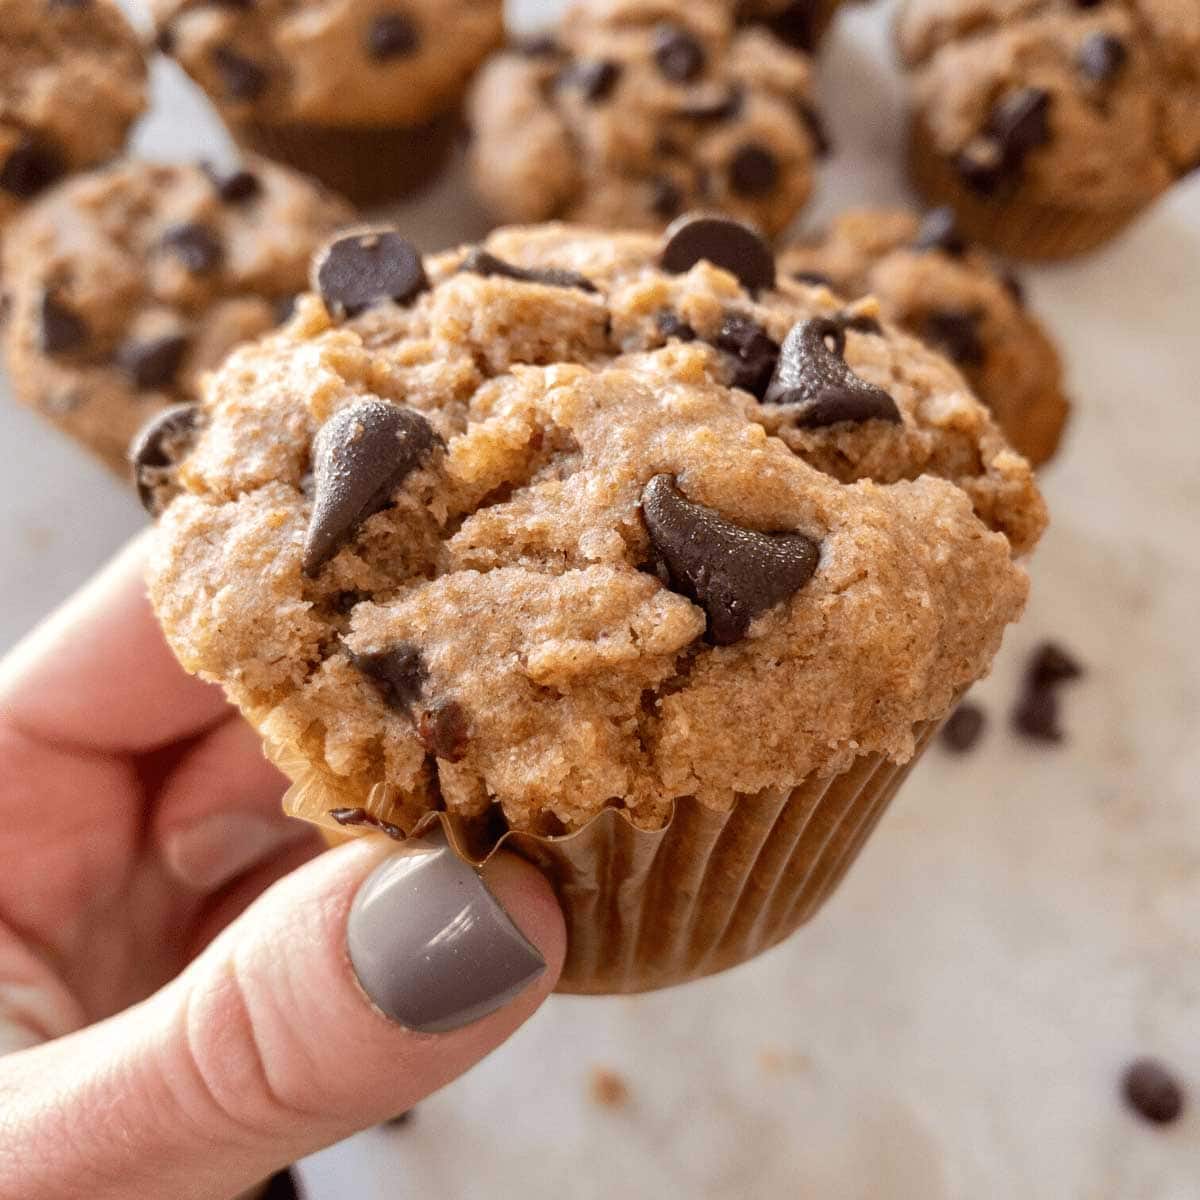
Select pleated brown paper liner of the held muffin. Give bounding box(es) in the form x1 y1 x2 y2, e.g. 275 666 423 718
266 722 940 995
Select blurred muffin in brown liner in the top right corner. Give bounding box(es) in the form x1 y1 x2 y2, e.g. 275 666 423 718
898 0 1200 258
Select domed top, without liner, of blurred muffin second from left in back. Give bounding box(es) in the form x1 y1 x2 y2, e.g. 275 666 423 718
150 0 504 126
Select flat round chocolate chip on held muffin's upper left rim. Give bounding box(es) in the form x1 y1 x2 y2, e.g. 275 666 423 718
317 232 430 318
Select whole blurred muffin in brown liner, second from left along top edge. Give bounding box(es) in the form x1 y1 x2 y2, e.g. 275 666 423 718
150 0 504 205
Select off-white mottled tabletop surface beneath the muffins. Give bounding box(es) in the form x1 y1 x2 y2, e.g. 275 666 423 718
0 0 1200 1200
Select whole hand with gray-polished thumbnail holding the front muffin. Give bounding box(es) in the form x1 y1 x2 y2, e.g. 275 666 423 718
0 541 564 1200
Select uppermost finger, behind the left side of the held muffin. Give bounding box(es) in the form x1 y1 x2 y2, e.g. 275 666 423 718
0 534 228 754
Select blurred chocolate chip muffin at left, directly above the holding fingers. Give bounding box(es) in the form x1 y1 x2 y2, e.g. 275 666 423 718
4 158 353 474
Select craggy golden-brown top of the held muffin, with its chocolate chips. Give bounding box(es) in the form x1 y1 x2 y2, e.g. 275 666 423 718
148 221 1044 834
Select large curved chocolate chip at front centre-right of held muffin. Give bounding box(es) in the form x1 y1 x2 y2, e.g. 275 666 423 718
642 475 821 646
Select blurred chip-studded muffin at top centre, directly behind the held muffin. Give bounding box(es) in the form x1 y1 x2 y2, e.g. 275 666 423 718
469 0 826 233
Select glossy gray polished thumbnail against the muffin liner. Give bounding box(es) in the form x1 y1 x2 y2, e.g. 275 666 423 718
347 839 546 1033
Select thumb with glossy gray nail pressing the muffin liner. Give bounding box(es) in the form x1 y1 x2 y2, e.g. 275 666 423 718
0 838 565 1200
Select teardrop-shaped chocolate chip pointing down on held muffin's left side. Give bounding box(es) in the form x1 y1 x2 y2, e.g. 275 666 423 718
304 400 442 576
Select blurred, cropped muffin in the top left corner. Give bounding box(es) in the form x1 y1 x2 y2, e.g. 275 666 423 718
0 0 146 226
